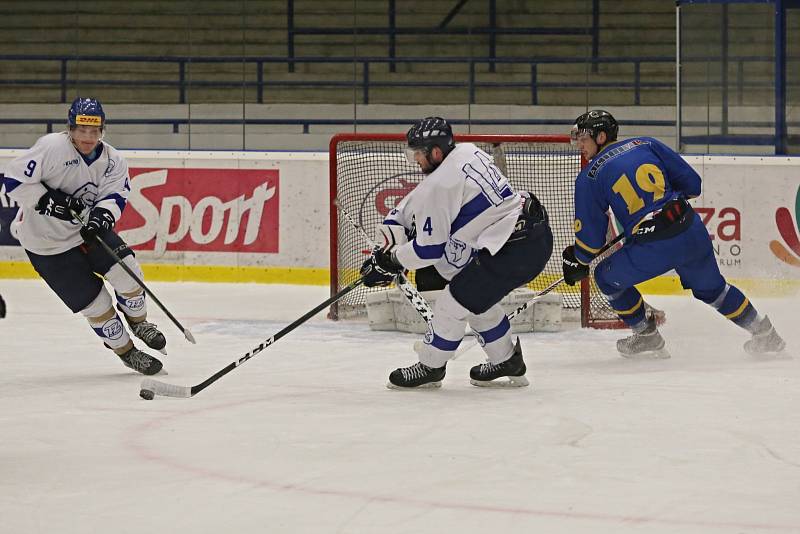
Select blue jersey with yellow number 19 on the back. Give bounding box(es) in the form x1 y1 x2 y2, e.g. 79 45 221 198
575 137 700 263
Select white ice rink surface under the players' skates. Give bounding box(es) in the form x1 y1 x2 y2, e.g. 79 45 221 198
0 280 800 534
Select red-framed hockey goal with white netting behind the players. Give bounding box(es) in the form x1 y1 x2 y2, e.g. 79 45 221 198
330 133 622 328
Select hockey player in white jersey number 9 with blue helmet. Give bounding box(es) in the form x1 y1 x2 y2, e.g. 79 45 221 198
3 98 166 375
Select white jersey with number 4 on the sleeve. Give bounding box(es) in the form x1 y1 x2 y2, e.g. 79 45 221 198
384 143 523 280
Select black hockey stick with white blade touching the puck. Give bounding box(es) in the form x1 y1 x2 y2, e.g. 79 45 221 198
139 278 364 400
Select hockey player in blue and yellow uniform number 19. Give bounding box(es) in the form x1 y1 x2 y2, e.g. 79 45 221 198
562 110 785 358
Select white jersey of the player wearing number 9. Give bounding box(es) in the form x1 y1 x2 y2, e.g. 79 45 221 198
4 132 130 256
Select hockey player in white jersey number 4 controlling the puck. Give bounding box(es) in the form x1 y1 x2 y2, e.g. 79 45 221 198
361 117 553 389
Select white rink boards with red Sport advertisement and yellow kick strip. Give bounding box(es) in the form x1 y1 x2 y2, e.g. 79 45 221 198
0 150 800 295
